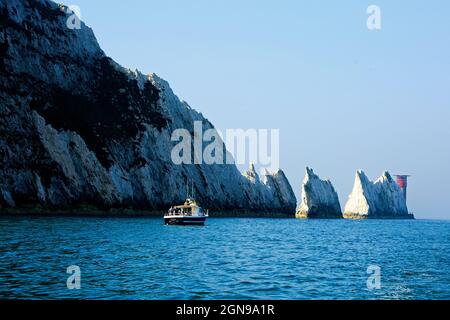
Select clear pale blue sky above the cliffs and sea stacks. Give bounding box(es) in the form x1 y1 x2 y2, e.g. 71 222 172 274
64 0 450 219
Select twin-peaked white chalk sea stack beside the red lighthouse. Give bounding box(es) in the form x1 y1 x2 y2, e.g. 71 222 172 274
344 170 414 219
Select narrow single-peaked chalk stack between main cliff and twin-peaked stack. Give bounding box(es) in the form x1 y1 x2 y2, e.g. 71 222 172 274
296 168 342 219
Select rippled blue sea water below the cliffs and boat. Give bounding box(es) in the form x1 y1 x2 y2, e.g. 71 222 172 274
0 217 450 299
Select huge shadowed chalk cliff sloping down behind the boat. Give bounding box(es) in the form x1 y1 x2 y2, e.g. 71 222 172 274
0 0 296 215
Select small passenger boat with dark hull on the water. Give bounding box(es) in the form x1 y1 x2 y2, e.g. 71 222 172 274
164 197 208 226
